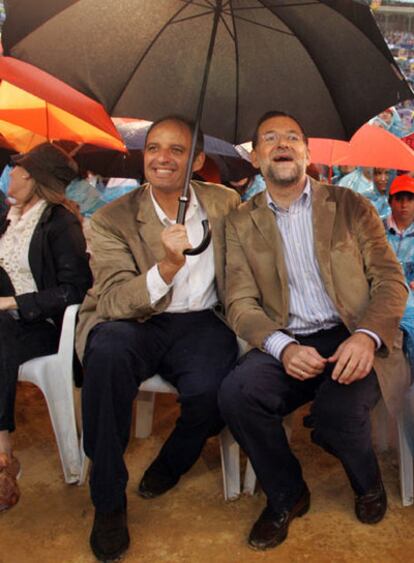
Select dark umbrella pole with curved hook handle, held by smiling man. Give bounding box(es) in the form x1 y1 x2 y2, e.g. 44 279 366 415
177 0 222 255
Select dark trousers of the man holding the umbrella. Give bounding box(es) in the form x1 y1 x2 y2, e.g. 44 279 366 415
82 310 237 512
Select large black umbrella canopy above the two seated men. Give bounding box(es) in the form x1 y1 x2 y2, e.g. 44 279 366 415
2 0 413 144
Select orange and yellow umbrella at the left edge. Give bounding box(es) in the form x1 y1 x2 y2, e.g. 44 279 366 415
0 56 126 152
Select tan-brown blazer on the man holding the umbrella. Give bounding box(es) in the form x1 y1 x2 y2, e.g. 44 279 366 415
76 182 240 358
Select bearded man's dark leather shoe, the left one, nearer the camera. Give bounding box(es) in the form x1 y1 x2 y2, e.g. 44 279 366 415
248 485 310 550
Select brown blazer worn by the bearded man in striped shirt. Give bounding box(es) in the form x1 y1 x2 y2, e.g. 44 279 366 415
226 180 409 412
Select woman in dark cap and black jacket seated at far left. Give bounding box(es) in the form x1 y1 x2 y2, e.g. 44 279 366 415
0 143 92 511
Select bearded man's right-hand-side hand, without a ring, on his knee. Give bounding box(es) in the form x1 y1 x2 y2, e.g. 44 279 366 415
328 332 376 385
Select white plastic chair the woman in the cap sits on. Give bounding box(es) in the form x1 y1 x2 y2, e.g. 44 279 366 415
18 305 81 483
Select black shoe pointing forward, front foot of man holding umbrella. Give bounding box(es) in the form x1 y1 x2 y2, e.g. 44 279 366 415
89 509 129 563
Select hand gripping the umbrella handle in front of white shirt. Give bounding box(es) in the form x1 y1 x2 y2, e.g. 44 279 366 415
158 225 192 284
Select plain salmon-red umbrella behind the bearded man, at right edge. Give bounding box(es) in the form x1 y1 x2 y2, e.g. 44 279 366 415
309 124 414 170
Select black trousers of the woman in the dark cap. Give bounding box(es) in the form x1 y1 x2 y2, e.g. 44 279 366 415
0 311 59 432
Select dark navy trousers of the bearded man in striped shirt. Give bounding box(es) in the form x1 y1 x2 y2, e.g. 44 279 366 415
219 326 380 511
